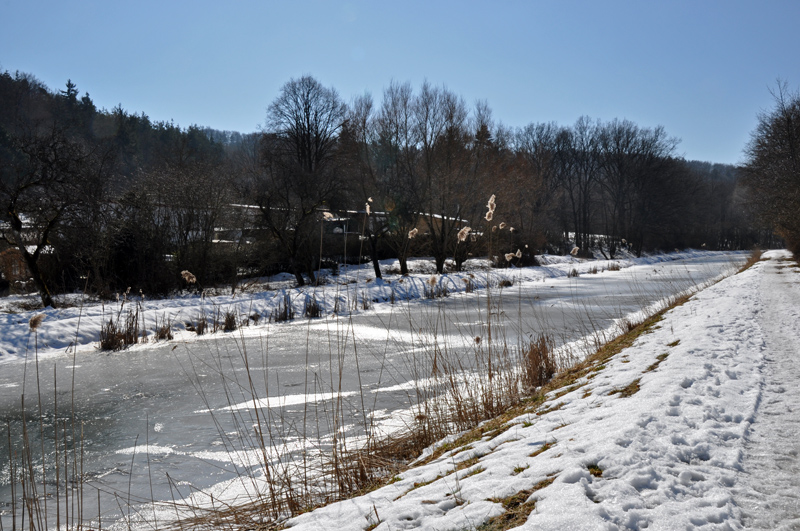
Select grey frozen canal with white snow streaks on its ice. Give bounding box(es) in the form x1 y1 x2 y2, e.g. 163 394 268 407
0 253 744 529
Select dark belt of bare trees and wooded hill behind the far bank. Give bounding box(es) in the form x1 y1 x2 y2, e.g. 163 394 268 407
0 72 771 304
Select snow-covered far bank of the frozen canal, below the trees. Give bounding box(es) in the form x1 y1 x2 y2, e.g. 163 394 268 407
0 250 714 363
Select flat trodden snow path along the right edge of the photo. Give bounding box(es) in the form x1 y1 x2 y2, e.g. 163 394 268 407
737 255 800 530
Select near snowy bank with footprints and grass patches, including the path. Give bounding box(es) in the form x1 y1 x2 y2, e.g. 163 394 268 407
288 252 800 531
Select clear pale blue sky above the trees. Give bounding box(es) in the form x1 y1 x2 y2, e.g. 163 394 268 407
0 0 800 163
